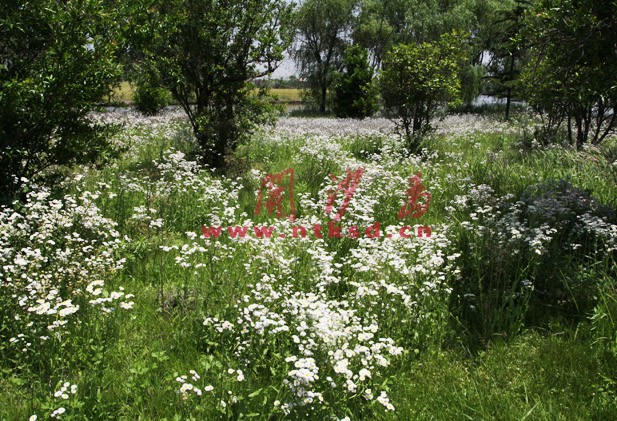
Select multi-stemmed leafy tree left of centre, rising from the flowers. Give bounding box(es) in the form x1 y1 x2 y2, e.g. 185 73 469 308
132 0 292 167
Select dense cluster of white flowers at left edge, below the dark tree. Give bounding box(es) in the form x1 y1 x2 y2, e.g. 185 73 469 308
0 188 132 351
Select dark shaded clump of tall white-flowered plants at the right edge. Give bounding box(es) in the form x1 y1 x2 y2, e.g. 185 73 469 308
451 180 617 343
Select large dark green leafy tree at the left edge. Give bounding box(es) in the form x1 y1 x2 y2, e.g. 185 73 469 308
0 0 120 198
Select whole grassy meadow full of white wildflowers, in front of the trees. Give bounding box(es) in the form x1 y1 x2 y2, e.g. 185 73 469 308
0 113 617 420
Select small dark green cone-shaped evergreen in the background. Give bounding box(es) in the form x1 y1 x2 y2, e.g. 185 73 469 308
334 45 379 118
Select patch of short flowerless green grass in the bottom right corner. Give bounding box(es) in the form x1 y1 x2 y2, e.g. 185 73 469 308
393 330 617 420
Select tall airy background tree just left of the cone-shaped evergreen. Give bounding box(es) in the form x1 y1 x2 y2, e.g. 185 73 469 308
293 0 355 113
